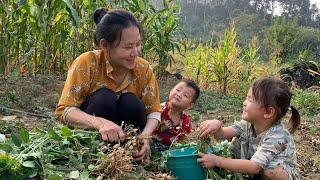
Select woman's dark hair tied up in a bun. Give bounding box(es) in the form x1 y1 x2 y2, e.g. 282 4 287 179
93 7 143 46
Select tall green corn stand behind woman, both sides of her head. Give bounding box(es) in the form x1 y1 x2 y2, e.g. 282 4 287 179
0 0 181 74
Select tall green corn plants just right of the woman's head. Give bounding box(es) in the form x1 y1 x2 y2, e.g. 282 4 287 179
115 0 184 75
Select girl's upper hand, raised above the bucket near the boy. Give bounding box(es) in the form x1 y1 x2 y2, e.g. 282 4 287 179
199 120 222 137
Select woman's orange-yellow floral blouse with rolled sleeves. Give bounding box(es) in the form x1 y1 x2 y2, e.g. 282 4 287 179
55 50 161 122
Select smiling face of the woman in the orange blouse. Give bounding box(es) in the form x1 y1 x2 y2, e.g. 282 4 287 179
104 26 141 71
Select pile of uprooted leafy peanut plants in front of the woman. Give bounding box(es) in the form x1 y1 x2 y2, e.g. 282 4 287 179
0 125 172 179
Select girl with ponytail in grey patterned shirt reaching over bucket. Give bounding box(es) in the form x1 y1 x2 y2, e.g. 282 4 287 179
198 77 300 180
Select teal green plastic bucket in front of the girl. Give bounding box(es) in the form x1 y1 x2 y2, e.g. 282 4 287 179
166 146 206 180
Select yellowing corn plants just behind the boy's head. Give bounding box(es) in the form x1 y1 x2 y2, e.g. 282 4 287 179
183 27 241 94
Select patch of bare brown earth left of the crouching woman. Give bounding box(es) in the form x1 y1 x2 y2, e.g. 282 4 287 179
0 76 63 129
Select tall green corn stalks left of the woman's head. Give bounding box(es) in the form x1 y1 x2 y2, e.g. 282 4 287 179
0 0 110 74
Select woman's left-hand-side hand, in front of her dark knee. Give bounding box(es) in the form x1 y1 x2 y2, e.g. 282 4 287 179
97 118 125 142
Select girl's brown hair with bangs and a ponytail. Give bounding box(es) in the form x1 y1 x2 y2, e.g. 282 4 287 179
252 77 300 133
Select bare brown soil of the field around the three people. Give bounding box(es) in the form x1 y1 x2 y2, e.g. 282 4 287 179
0 75 320 179
